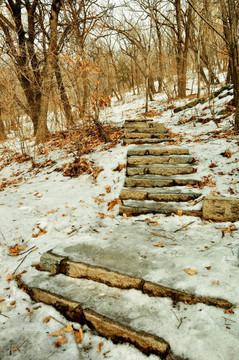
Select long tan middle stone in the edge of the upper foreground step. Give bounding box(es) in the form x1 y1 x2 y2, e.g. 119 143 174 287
61 260 142 289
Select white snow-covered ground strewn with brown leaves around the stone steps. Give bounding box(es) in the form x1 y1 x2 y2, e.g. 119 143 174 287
0 88 239 360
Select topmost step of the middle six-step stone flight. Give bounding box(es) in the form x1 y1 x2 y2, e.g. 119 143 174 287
127 146 189 157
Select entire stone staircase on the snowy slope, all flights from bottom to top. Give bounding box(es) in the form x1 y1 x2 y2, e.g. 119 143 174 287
19 120 215 360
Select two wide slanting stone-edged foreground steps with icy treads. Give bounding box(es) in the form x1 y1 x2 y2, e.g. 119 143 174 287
19 235 233 360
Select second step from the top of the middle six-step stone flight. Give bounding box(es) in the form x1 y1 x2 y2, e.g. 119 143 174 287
127 155 193 165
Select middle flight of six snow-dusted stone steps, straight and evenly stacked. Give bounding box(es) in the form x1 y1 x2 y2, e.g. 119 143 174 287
119 145 202 216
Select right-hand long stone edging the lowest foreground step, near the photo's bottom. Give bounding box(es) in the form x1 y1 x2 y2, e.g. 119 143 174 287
84 309 170 356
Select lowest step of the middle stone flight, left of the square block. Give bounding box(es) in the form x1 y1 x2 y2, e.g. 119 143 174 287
119 200 202 217
